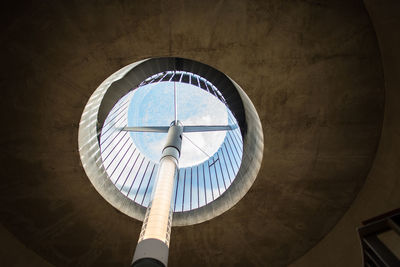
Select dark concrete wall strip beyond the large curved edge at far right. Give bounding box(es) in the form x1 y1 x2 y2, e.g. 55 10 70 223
291 0 400 267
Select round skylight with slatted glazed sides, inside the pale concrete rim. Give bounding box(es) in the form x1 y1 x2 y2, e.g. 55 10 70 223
100 71 243 212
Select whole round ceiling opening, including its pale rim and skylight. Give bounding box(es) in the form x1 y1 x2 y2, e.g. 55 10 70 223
79 58 263 225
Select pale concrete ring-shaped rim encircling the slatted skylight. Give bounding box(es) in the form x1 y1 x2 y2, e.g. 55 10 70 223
78 57 264 226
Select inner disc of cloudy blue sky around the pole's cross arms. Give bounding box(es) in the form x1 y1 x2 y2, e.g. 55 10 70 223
128 82 228 167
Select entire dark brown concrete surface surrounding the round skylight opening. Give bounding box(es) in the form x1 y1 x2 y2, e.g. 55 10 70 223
0 0 394 266
